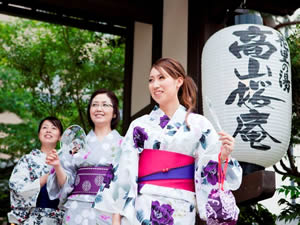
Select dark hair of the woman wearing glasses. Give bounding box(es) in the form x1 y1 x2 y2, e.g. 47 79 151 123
87 88 120 130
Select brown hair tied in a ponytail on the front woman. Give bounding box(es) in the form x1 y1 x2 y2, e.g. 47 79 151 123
152 58 198 113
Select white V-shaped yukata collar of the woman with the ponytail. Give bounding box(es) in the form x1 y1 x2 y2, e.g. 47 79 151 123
150 105 186 128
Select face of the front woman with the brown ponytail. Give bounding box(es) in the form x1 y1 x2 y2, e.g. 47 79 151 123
149 68 183 106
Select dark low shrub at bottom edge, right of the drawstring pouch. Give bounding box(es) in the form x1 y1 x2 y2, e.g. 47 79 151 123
237 203 276 225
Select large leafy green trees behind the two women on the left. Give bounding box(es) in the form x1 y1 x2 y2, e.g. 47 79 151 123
0 19 124 157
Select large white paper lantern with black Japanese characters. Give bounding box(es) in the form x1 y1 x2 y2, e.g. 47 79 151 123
202 24 292 167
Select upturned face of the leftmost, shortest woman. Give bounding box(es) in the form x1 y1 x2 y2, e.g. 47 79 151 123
39 120 61 145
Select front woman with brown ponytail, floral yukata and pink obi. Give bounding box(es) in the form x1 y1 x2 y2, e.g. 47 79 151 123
94 58 242 225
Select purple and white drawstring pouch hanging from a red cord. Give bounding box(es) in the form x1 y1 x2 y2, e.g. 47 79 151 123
206 189 239 225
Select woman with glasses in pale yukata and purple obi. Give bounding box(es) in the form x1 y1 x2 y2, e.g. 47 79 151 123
47 89 122 225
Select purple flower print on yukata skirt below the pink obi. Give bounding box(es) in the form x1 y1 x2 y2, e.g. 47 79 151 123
150 201 174 225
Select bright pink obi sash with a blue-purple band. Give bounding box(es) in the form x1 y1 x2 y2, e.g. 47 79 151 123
138 149 195 192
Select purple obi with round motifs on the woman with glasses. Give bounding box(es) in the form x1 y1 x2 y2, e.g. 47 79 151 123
72 164 114 195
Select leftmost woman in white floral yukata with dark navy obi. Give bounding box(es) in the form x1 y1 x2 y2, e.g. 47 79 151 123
8 117 63 225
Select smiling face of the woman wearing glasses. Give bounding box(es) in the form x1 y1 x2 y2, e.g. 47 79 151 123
90 94 114 127
